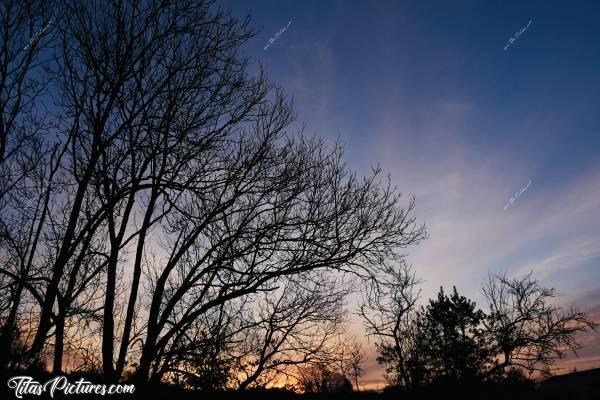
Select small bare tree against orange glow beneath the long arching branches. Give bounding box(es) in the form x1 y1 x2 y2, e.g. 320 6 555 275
233 272 350 389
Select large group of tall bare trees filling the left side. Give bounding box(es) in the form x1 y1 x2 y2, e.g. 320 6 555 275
0 0 425 389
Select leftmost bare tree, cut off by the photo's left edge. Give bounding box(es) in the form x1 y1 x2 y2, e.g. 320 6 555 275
0 0 57 368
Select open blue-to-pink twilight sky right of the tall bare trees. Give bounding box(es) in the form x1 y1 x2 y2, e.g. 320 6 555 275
218 0 600 383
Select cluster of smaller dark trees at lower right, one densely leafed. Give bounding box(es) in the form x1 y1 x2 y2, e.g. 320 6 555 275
360 266 597 390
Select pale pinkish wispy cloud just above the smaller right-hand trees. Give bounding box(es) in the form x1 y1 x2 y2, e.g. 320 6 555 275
372 105 600 295
